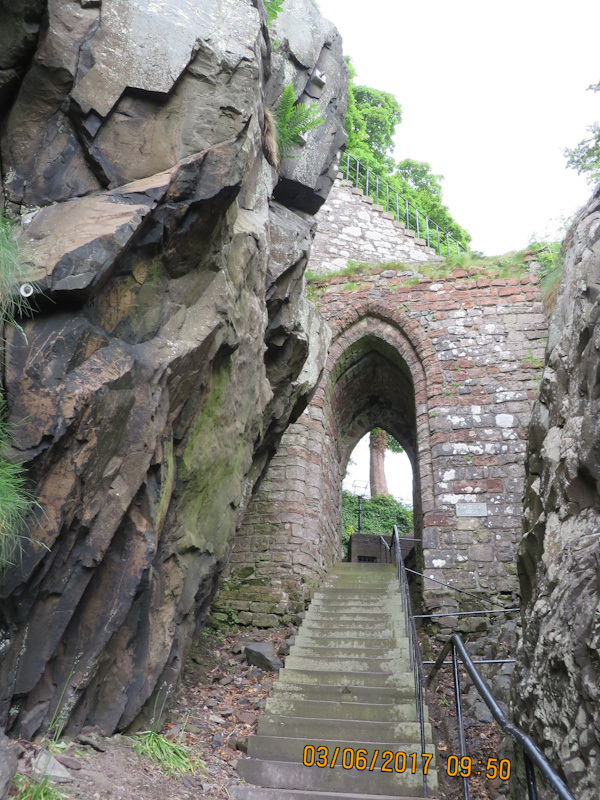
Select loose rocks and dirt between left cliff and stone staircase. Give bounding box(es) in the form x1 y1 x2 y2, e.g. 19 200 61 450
10 627 296 800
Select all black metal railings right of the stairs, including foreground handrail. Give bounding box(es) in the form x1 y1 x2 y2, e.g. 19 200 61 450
380 525 575 800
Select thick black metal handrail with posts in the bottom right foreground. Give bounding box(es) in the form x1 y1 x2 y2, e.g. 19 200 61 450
426 633 575 800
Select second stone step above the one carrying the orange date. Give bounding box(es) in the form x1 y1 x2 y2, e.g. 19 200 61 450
266 695 416 727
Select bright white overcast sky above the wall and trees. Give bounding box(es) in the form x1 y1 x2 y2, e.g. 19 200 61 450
318 0 600 255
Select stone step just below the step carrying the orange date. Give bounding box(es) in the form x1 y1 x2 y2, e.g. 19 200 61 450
238 758 437 797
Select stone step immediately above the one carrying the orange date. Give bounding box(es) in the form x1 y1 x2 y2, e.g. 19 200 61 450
258 714 431 744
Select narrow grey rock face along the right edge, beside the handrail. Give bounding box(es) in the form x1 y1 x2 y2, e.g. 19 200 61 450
513 190 600 800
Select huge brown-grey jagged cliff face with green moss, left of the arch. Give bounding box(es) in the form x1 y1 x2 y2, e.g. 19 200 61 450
0 0 347 737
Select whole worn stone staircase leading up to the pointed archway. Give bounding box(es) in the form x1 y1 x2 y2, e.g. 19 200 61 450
230 563 437 800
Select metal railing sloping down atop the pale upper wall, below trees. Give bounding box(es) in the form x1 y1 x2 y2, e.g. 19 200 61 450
340 152 468 258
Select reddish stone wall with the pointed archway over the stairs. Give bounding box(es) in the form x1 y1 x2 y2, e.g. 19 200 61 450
221 269 547 630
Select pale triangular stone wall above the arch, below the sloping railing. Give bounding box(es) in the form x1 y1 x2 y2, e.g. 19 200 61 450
310 174 437 274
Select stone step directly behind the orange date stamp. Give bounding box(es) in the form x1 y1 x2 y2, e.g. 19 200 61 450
248 736 436 769
